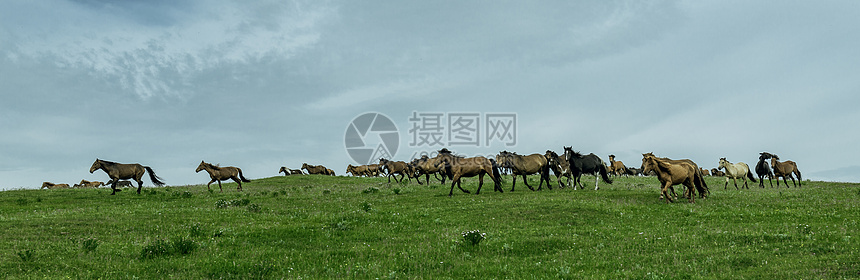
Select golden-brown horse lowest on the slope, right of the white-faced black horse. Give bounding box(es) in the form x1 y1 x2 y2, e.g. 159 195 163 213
642 153 705 203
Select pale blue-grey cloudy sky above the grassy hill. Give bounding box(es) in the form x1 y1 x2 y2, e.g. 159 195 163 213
0 0 860 189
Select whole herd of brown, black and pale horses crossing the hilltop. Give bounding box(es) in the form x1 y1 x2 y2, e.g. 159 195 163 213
42 151 803 203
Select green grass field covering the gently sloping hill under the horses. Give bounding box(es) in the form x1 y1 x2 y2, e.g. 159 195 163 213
0 175 860 279
